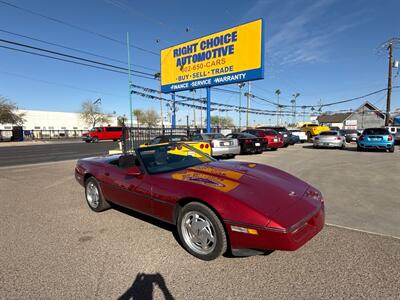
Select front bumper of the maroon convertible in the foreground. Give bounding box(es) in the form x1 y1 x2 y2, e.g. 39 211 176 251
225 204 325 251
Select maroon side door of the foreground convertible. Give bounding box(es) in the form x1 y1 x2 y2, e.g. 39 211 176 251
103 164 151 214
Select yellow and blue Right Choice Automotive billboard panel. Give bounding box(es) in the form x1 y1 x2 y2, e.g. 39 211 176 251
161 19 264 93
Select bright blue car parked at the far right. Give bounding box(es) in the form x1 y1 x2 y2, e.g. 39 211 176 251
357 128 394 152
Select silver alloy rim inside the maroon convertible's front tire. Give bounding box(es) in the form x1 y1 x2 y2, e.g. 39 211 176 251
180 211 217 255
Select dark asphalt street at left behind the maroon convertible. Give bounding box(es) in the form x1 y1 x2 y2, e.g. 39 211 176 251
0 141 118 167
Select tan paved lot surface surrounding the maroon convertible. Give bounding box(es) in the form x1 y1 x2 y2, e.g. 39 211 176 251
0 145 400 299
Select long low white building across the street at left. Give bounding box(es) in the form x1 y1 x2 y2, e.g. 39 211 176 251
0 109 117 130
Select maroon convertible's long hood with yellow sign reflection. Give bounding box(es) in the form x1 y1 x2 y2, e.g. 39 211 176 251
171 162 309 216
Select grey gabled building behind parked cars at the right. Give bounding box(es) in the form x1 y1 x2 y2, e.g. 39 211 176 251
317 101 385 129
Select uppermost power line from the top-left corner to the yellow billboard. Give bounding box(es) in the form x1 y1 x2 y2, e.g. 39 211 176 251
0 0 160 56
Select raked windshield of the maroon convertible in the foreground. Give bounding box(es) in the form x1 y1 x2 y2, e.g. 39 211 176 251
136 143 214 174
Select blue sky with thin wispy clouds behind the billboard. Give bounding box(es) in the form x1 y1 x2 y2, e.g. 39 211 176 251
0 0 400 124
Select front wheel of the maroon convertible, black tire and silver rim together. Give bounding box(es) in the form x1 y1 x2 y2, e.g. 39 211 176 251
177 202 228 260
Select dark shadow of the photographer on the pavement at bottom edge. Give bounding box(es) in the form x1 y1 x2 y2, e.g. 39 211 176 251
118 273 175 300
